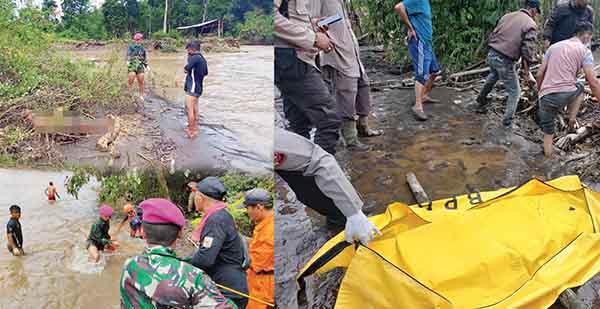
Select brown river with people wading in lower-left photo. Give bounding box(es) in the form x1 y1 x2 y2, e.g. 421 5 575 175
0 169 143 309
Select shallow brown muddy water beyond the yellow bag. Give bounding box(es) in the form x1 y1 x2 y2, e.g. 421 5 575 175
338 84 562 213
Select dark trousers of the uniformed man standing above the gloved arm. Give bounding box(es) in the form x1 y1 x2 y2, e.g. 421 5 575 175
275 52 341 154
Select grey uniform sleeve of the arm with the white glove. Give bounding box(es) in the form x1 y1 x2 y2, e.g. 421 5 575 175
274 128 363 218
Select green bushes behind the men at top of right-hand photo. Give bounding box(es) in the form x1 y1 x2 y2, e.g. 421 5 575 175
352 0 600 71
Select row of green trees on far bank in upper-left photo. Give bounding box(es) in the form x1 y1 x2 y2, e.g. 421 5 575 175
12 0 272 40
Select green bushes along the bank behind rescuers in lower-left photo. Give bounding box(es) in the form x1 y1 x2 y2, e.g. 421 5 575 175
67 167 274 236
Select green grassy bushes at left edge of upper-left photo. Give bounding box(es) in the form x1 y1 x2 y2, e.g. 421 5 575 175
0 0 134 162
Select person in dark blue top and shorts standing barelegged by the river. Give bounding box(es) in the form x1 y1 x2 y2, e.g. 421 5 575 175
183 40 208 138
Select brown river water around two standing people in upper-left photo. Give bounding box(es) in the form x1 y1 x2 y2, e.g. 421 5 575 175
64 45 273 174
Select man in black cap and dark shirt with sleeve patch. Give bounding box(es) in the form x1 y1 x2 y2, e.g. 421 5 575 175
191 177 248 308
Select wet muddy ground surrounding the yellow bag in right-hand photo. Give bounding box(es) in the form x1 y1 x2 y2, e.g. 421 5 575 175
275 48 600 308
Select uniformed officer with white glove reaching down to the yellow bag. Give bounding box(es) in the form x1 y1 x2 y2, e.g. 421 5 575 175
274 129 381 245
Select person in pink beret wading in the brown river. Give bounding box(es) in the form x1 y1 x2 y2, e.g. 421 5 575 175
87 205 117 263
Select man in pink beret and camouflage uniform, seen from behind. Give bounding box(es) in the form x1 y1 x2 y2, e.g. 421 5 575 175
120 199 237 308
